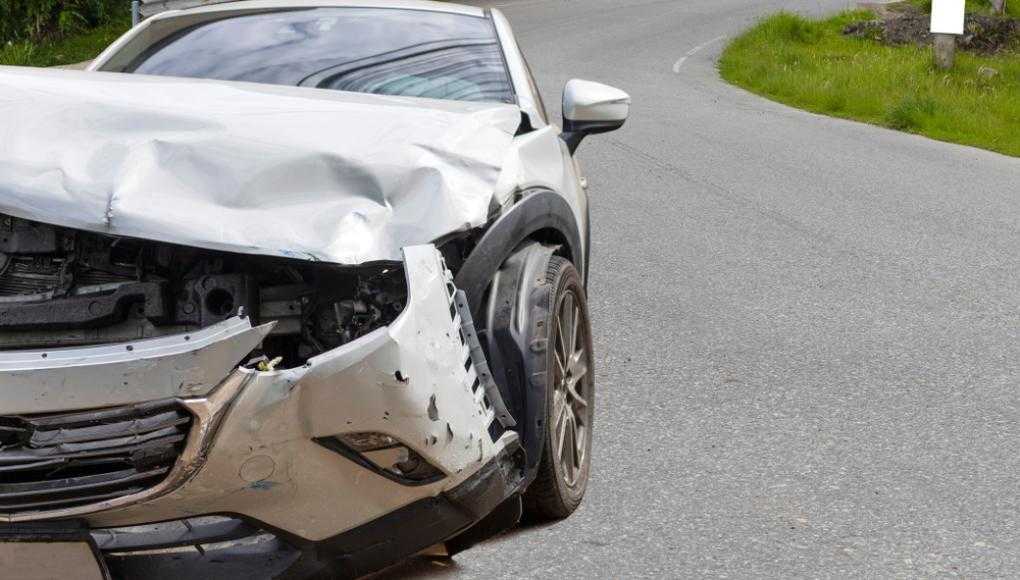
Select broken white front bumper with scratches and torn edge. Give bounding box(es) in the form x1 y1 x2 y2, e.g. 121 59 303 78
0 246 519 574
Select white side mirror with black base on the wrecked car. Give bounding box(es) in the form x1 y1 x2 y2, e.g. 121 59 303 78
563 78 630 154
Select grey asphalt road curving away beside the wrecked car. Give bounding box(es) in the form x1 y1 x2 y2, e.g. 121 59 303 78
373 0 1020 578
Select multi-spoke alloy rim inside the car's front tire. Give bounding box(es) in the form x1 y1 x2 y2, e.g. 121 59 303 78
553 292 592 487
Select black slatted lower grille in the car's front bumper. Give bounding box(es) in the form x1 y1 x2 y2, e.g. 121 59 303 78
0 401 192 513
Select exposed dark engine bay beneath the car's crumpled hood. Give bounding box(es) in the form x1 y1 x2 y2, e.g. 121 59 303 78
0 215 407 367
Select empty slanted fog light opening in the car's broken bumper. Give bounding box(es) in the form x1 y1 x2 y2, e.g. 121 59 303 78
315 432 445 485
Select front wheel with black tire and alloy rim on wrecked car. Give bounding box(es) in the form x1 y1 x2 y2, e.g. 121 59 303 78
524 256 595 522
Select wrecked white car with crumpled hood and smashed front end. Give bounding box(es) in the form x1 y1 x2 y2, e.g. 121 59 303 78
0 0 629 578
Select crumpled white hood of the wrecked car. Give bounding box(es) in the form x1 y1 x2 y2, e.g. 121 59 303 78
0 67 520 264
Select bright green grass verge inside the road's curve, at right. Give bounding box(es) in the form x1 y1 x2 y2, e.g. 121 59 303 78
719 12 1020 157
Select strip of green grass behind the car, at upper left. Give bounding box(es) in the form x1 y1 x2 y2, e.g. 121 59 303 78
0 13 131 66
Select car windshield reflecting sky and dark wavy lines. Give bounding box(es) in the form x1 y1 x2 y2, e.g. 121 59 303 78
124 8 514 103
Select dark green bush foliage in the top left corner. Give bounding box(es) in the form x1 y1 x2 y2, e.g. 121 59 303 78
0 0 130 45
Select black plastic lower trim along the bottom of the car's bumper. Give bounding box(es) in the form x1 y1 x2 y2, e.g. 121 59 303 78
91 433 524 580
